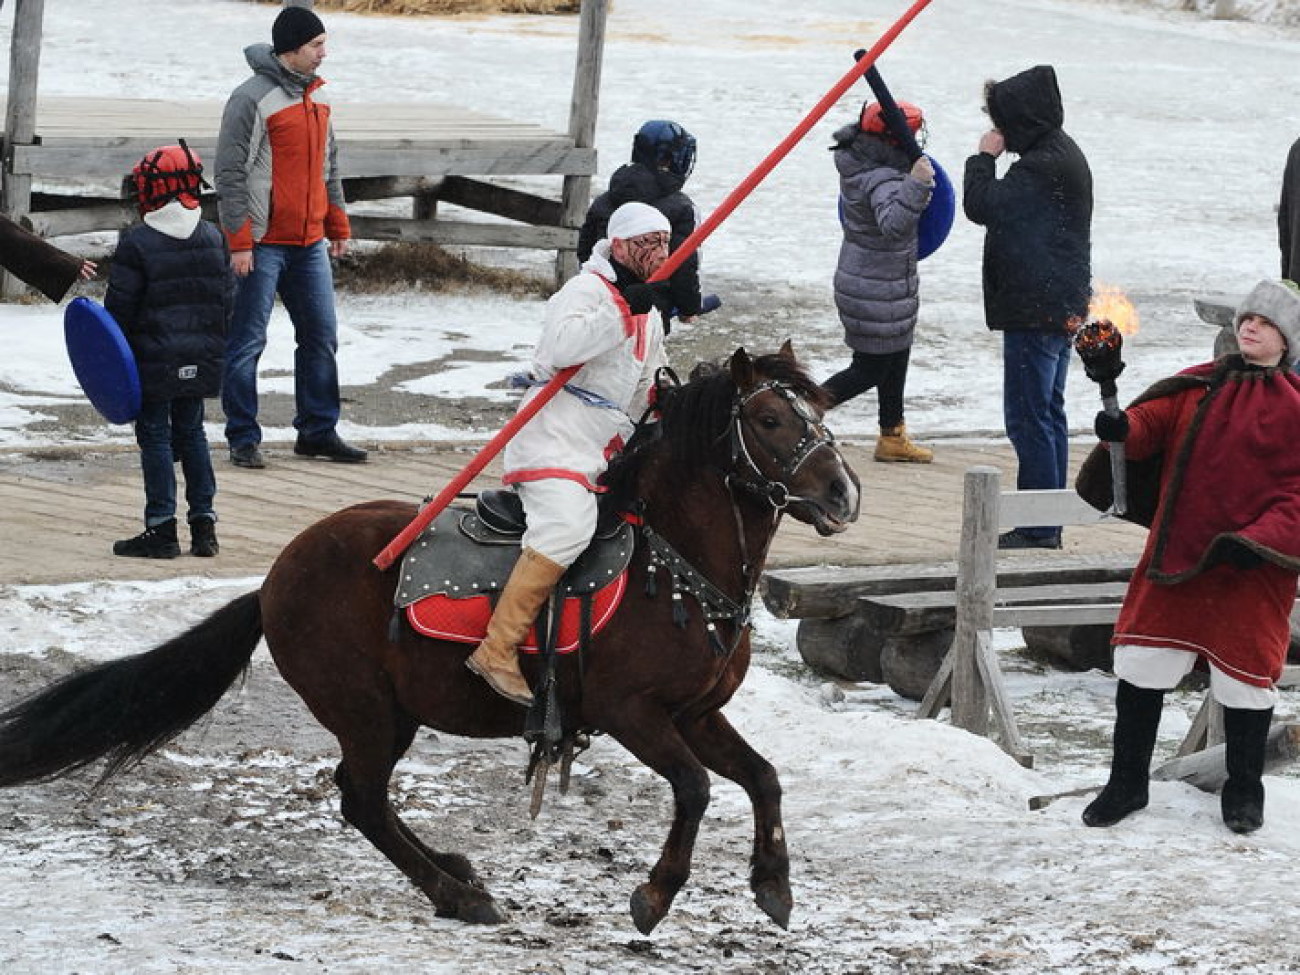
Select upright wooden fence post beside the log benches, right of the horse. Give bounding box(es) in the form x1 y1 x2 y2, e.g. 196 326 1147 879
949 467 1001 735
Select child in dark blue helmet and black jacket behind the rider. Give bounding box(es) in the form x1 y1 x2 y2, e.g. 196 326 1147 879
577 120 701 334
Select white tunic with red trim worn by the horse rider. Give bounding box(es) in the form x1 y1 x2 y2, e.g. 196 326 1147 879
502 241 664 490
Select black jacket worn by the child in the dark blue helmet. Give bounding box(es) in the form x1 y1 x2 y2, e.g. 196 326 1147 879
577 163 699 316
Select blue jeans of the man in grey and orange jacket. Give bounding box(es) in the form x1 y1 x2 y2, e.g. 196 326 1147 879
221 241 339 447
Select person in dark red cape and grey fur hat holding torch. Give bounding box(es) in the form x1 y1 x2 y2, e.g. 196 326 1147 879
1078 281 1300 833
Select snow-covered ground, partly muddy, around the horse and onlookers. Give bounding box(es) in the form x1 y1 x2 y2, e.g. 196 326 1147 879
0 0 1300 975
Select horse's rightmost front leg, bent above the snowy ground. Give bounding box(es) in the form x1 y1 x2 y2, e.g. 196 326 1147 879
680 711 794 928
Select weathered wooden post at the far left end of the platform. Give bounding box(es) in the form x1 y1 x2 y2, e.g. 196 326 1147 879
0 0 46 298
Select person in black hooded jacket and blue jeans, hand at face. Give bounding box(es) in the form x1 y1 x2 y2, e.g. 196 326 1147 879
962 65 1092 549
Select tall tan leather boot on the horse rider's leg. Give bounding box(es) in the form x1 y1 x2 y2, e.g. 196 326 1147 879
465 549 566 705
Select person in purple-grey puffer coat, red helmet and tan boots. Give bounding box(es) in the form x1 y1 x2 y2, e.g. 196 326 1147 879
822 101 935 464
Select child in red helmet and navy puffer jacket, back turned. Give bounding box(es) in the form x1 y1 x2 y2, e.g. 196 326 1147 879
104 140 234 559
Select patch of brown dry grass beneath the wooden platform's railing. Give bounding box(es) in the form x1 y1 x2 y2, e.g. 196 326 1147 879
334 243 555 298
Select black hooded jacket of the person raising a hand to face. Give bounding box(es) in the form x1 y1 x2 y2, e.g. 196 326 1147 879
962 65 1092 332
